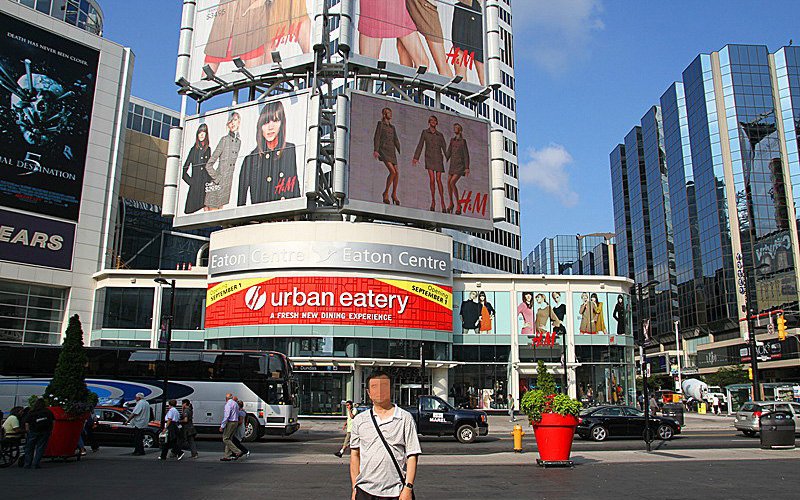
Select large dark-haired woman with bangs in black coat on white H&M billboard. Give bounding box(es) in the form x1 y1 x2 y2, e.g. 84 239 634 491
237 101 300 207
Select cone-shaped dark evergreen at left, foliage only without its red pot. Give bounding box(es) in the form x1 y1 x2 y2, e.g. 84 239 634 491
44 314 97 413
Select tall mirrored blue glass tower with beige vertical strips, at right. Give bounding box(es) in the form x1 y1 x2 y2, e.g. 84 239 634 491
610 45 800 381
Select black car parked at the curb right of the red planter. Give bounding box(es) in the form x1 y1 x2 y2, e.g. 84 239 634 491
575 406 681 441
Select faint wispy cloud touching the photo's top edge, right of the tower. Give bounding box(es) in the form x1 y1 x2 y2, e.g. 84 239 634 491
511 0 605 74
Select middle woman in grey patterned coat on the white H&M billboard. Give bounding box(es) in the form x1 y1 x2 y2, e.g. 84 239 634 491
205 111 242 211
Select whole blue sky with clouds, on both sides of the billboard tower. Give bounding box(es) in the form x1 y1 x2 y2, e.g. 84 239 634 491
102 0 800 257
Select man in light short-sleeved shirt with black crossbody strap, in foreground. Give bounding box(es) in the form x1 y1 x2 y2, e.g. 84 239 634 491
350 370 422 500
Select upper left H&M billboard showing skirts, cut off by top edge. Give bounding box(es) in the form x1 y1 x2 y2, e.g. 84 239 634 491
189 0 314 81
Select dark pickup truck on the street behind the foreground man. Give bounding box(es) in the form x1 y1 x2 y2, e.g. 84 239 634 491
403 396 489 443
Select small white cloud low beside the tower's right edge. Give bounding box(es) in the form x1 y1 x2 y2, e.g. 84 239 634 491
519 143 578 207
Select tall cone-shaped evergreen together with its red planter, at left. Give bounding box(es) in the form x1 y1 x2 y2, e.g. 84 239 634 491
34 314 97 457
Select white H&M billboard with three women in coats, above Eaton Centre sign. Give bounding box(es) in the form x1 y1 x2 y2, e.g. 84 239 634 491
175 92 308 226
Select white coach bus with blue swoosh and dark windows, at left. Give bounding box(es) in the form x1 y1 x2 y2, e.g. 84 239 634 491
0 344 300 441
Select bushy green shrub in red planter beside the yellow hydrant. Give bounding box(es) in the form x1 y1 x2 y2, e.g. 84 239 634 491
520 361 581 464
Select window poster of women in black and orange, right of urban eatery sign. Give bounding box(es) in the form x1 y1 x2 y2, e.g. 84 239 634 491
453 290 511 335
